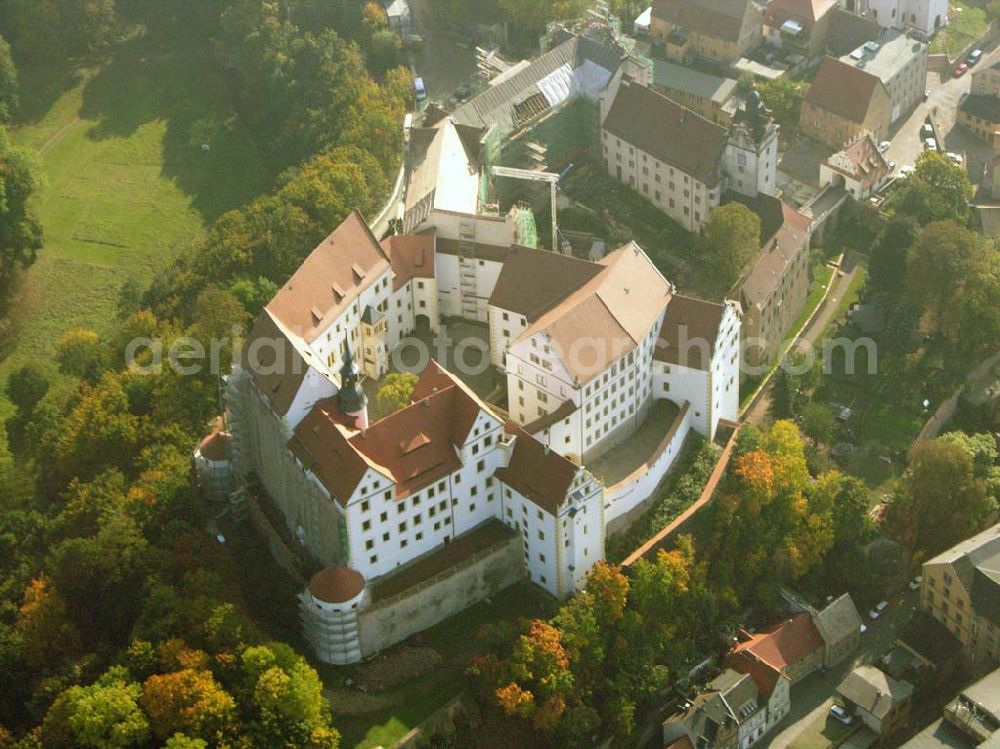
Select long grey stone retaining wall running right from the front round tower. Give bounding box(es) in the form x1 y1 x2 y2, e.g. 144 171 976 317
358 534 526 656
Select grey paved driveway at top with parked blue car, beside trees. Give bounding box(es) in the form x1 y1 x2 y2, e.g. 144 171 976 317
409 0 476 102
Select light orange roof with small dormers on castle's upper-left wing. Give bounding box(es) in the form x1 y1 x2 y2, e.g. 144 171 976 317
266 211 389 343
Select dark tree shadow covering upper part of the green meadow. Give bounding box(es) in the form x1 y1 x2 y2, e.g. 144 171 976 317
80 5 282 222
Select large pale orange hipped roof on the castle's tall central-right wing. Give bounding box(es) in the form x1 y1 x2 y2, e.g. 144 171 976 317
518 242 673 383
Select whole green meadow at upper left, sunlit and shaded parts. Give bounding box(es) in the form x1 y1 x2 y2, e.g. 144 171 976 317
0 17 271 394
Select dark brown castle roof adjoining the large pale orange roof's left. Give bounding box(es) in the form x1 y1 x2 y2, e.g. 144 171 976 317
490 245 605 322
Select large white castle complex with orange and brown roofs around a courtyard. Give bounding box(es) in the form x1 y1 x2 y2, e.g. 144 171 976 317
229 203 739 663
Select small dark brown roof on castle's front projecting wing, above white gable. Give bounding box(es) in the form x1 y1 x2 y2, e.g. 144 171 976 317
496 424 580 515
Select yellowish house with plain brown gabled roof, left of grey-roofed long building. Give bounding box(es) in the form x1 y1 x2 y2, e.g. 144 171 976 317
799 57 892 151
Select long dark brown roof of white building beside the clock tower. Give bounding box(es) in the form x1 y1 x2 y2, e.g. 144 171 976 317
604 80 726 188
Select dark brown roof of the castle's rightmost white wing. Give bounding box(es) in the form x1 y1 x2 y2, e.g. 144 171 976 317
653 294 726 370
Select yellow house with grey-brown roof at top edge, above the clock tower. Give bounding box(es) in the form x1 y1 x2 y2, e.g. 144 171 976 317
649 0 763 63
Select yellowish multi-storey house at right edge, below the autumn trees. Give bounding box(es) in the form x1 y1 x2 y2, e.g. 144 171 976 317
920 525 1000 671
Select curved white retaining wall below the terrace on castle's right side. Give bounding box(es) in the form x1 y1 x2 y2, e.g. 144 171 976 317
604 401 691 536
